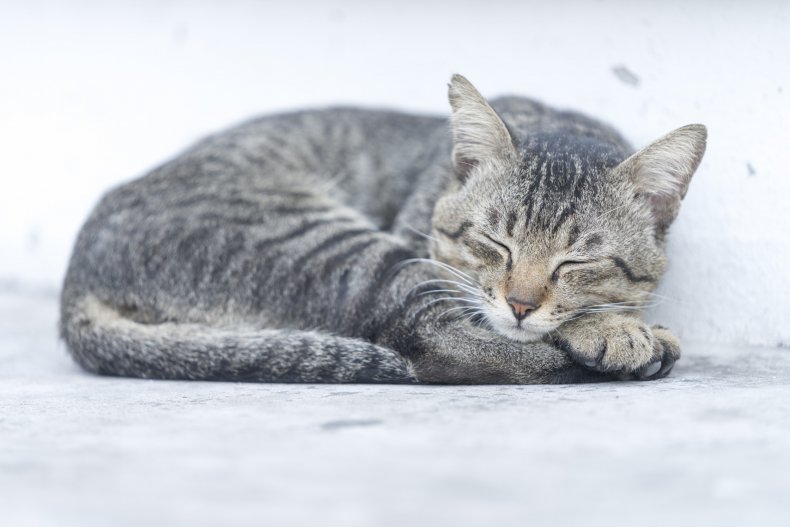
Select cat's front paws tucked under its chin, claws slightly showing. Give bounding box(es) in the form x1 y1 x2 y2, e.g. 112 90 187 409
555 314 680 380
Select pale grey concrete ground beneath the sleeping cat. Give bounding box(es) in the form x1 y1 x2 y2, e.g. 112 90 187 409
0 294 790 526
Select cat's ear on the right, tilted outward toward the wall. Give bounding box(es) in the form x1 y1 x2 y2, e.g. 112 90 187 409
618 124 708 230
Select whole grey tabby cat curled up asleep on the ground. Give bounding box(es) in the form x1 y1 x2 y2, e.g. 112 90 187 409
61 75 706 383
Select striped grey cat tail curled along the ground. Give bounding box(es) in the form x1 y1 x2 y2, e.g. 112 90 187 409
60 296 417 384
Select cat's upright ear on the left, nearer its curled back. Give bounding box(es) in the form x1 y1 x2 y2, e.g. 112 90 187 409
448 74 516 181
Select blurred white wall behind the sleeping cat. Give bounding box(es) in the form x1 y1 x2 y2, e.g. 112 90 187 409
0 0 790 345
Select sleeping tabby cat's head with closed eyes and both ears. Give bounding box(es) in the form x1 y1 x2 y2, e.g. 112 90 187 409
431 75 706 341
